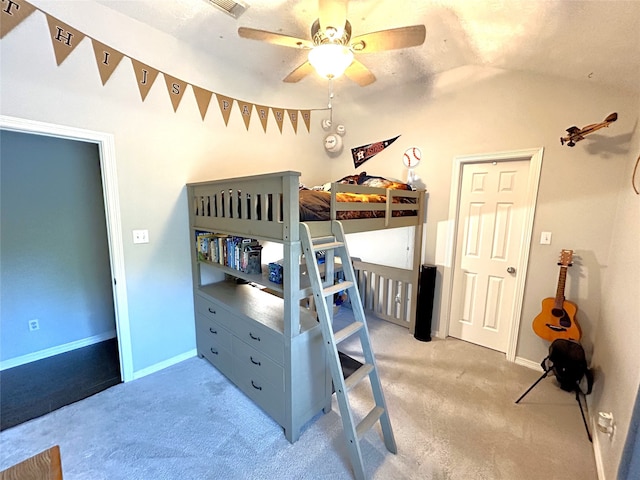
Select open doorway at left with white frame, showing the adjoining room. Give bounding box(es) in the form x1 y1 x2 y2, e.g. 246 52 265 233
0 117 133 428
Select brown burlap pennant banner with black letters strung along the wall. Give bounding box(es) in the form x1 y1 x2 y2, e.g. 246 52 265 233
0 0 311 133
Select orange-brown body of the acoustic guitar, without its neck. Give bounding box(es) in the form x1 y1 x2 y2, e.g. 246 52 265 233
532 297 582 342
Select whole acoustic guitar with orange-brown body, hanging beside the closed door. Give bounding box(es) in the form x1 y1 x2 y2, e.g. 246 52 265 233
533 250 582 342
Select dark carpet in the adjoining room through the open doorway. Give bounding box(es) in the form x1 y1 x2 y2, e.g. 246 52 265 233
0 338 122 430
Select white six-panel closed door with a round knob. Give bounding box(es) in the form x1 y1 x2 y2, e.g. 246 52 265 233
449 160 530 352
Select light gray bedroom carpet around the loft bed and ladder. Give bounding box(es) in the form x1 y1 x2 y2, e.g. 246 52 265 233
0 308 597 480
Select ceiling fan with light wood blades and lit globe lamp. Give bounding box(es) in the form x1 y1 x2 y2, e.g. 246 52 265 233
238 0 426 87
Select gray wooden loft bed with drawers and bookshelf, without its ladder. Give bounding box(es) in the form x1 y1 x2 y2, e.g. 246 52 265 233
187 171 425 443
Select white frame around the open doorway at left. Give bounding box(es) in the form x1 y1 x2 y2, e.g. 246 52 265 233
0 115 134 382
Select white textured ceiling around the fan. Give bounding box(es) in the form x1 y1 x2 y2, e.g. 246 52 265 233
96 0 640 92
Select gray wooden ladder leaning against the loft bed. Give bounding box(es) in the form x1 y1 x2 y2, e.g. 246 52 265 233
300 220 397 480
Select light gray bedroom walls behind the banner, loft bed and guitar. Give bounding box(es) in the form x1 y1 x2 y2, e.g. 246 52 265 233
0 0 640 471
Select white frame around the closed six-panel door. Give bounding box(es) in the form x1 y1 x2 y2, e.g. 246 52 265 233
438 147 544 362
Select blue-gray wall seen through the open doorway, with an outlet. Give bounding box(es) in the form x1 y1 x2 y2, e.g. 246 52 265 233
0 130 115 361
